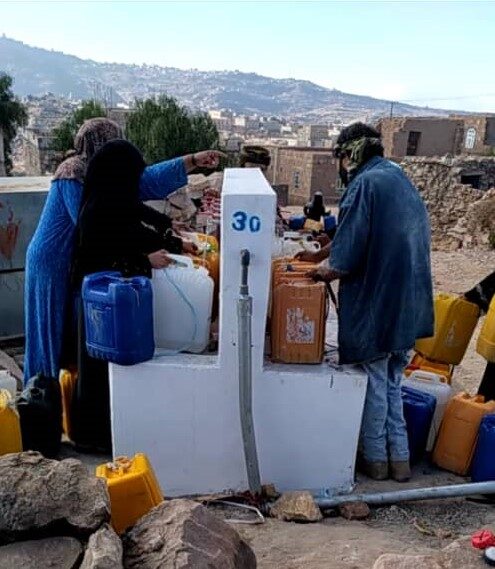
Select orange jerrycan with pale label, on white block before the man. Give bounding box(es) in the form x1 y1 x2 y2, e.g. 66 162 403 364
271 279 327 364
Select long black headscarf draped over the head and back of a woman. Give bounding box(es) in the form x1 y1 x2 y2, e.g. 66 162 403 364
73 140 151 286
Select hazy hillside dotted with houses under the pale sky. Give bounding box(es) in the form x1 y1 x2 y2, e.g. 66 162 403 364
0 36 454 122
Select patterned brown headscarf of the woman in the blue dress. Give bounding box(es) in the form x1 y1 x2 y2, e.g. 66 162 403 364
53 118 123 183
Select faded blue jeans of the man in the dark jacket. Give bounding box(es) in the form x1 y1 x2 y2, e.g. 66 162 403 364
361 352 409 462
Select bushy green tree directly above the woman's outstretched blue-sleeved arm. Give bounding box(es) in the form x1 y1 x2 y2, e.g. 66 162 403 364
126 95 219 164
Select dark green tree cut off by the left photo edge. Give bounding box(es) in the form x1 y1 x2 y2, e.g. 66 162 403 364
0 73 27 174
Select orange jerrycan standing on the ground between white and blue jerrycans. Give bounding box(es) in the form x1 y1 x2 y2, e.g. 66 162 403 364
432 393 495 476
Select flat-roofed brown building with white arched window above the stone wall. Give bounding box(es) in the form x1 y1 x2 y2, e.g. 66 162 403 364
379 115 495 158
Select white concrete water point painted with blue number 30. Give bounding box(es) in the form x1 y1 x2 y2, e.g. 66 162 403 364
110 169 367 496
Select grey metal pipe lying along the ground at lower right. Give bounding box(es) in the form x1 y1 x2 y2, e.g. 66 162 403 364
316 481 495 510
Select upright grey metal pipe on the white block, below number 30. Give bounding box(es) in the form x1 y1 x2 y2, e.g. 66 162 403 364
237 249 261 494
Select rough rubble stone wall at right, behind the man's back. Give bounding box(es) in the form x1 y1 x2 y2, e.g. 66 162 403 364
401 157 495 250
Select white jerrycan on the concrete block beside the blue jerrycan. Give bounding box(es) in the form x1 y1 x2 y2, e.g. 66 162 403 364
151 255 215 354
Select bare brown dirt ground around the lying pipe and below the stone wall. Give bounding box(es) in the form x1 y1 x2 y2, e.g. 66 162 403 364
238 251 495 569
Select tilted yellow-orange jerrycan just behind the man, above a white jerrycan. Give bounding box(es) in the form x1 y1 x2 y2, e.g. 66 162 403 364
416 293 480 365
